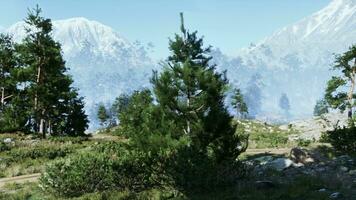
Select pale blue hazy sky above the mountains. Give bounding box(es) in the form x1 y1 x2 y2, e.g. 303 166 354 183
0 0 330 57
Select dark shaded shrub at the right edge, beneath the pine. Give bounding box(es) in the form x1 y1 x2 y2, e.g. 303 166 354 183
322 127 356 152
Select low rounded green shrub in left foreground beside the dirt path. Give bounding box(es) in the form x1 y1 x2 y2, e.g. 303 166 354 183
40 152 115 197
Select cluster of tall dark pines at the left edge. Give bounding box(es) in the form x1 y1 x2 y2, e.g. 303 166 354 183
0 7 88 137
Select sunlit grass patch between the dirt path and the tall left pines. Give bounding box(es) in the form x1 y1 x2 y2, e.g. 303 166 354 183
0 134 94 178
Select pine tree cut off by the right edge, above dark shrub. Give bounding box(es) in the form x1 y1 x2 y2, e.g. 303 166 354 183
325 45 356 120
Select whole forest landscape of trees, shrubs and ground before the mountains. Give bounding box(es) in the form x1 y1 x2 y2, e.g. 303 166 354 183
0 6 356 200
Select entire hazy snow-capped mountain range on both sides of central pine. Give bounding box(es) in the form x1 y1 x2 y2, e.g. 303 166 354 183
0 0 356 129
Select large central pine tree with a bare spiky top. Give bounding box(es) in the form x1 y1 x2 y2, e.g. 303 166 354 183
152 14 239 159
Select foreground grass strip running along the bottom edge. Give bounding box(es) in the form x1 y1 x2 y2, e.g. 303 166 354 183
0 173 355 200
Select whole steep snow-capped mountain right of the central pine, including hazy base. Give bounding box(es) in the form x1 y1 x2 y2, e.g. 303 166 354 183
217 0 356 118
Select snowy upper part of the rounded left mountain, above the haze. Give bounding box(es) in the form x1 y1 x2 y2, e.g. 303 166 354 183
7 17 150 64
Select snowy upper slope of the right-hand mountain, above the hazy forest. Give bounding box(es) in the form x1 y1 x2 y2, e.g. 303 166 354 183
240 0 356 69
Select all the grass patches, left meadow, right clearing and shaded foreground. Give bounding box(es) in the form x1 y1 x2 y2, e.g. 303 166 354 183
0 121 356 200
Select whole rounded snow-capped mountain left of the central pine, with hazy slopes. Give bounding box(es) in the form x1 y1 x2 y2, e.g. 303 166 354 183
6 18 155 128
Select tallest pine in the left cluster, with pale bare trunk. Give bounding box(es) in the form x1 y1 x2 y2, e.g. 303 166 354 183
17 6 87 137
